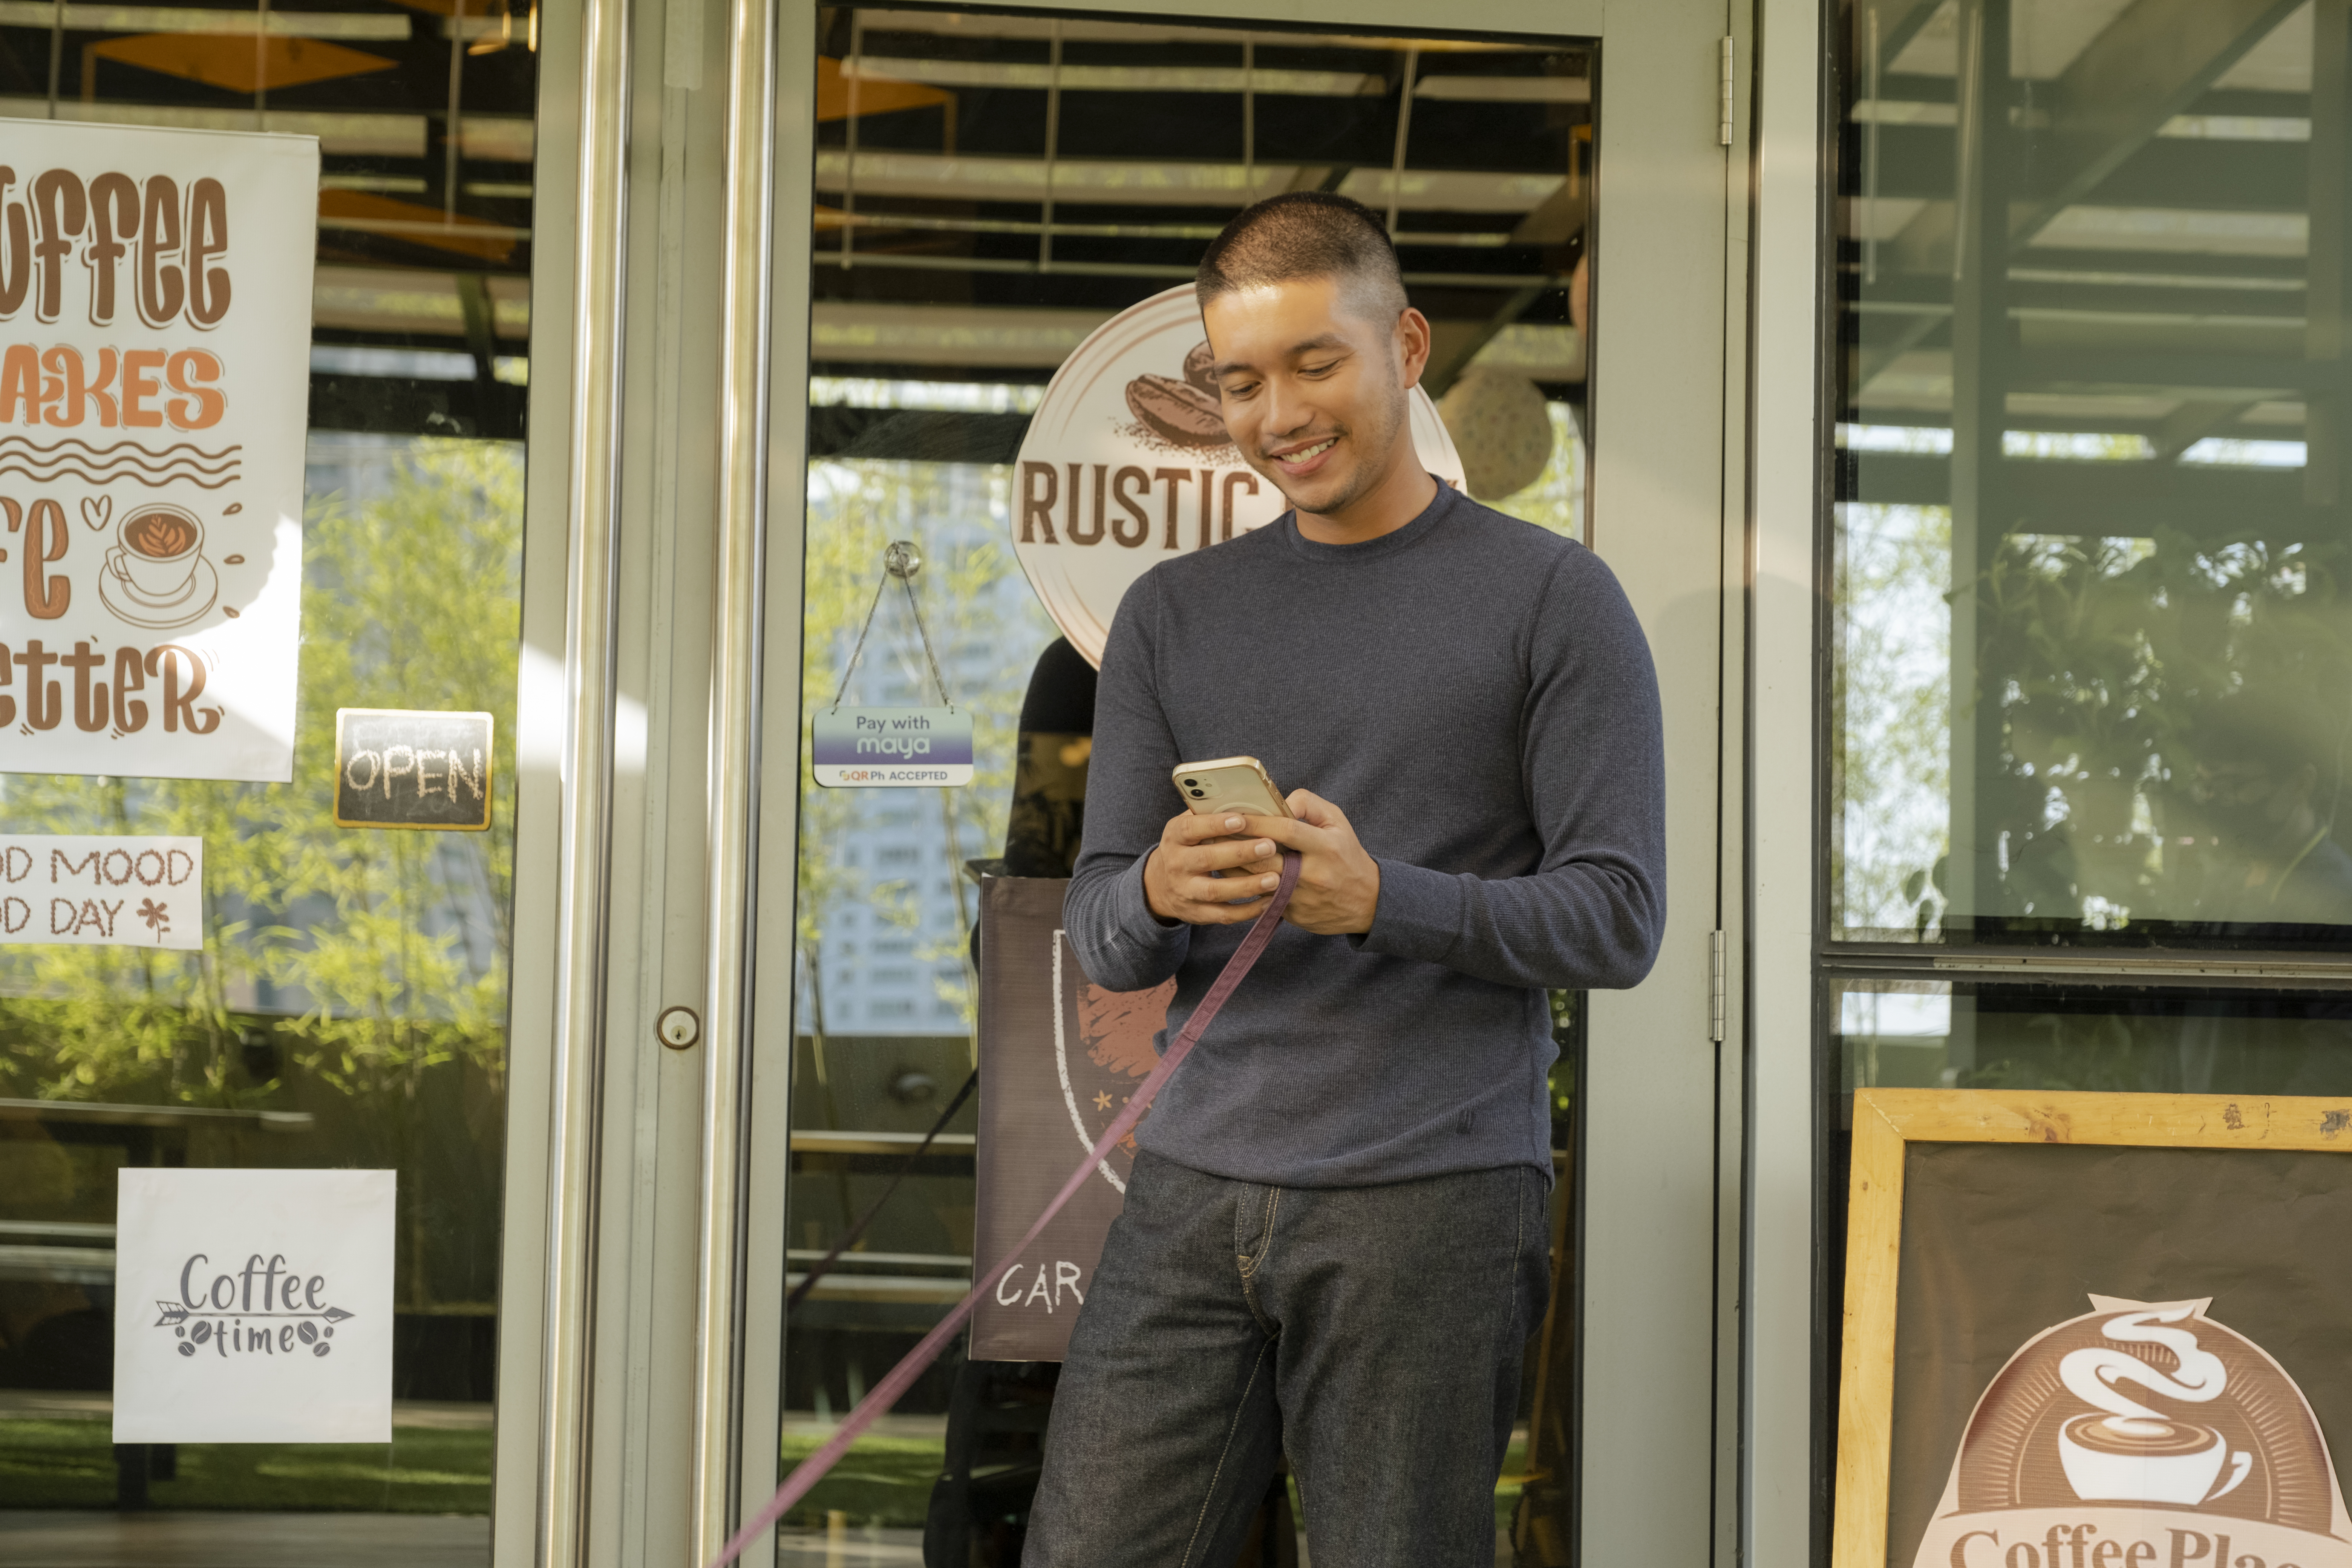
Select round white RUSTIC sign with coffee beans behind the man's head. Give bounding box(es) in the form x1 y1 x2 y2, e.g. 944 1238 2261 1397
1011 285 1463 665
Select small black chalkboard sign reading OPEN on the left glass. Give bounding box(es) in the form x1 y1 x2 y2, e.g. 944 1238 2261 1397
334 707 496 832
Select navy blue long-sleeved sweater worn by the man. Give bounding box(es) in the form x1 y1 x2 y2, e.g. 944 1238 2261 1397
1063 487 1665 1187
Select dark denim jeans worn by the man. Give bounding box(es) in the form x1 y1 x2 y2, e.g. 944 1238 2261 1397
1021 1154 1552 1568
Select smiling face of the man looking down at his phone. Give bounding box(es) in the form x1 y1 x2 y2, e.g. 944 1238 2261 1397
1202 277 1430 517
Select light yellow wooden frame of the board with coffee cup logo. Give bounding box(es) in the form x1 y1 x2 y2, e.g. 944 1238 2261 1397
1830 1089 2352 1568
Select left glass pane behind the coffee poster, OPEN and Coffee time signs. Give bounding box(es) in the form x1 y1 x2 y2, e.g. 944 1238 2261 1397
0 0 536 1563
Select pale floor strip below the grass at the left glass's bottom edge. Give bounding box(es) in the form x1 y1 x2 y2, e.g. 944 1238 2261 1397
0 1509 489 1568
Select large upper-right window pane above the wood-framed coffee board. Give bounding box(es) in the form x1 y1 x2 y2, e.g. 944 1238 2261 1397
1830 0 2352 947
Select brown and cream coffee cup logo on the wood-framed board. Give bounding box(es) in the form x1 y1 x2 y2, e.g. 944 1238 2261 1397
1912 1295 2352 1568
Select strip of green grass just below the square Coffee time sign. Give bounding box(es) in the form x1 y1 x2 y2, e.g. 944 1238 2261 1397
0 1415 492 1514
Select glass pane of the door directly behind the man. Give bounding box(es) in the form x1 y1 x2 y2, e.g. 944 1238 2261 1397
783 9 1592 1563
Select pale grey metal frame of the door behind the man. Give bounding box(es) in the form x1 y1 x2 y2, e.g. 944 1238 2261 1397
733 0 1747 1568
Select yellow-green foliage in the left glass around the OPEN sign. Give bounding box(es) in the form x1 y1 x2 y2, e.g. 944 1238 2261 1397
0 442 522 1107
